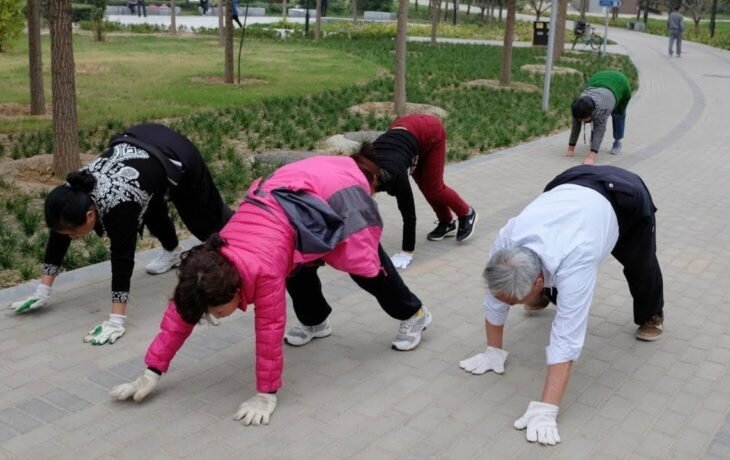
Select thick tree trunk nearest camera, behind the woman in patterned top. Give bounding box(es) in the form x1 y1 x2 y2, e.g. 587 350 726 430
51 0 81 177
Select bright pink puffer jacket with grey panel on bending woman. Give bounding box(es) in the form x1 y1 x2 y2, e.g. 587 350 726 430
145 156 382 392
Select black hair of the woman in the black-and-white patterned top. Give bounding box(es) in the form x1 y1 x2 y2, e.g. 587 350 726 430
44 170 96 231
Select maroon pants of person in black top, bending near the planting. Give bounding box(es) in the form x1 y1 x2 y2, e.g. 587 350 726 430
390 114 469 222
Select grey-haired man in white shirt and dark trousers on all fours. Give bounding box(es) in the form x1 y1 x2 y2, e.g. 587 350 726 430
459 165 664 445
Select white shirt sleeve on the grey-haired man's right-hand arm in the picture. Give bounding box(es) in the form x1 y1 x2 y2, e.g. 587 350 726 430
545 264 598 365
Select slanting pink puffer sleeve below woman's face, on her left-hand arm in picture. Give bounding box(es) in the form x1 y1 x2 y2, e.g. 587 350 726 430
144 300 195 372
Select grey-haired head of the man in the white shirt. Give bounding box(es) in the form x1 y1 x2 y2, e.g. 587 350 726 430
484 247 542 300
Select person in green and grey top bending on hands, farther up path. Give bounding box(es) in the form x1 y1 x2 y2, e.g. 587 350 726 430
566 70 631 165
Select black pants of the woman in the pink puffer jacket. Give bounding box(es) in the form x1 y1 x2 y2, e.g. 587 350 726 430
286 245 422 326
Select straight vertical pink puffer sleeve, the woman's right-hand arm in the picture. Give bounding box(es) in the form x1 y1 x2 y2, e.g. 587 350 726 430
253 277 286 393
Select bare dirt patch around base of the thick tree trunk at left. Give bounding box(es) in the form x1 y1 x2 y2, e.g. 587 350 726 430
0 154 97 191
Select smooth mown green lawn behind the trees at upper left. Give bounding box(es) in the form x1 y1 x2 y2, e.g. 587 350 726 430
0 35 378 133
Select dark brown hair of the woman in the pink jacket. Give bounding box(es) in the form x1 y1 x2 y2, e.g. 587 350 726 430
173 233 243 324
